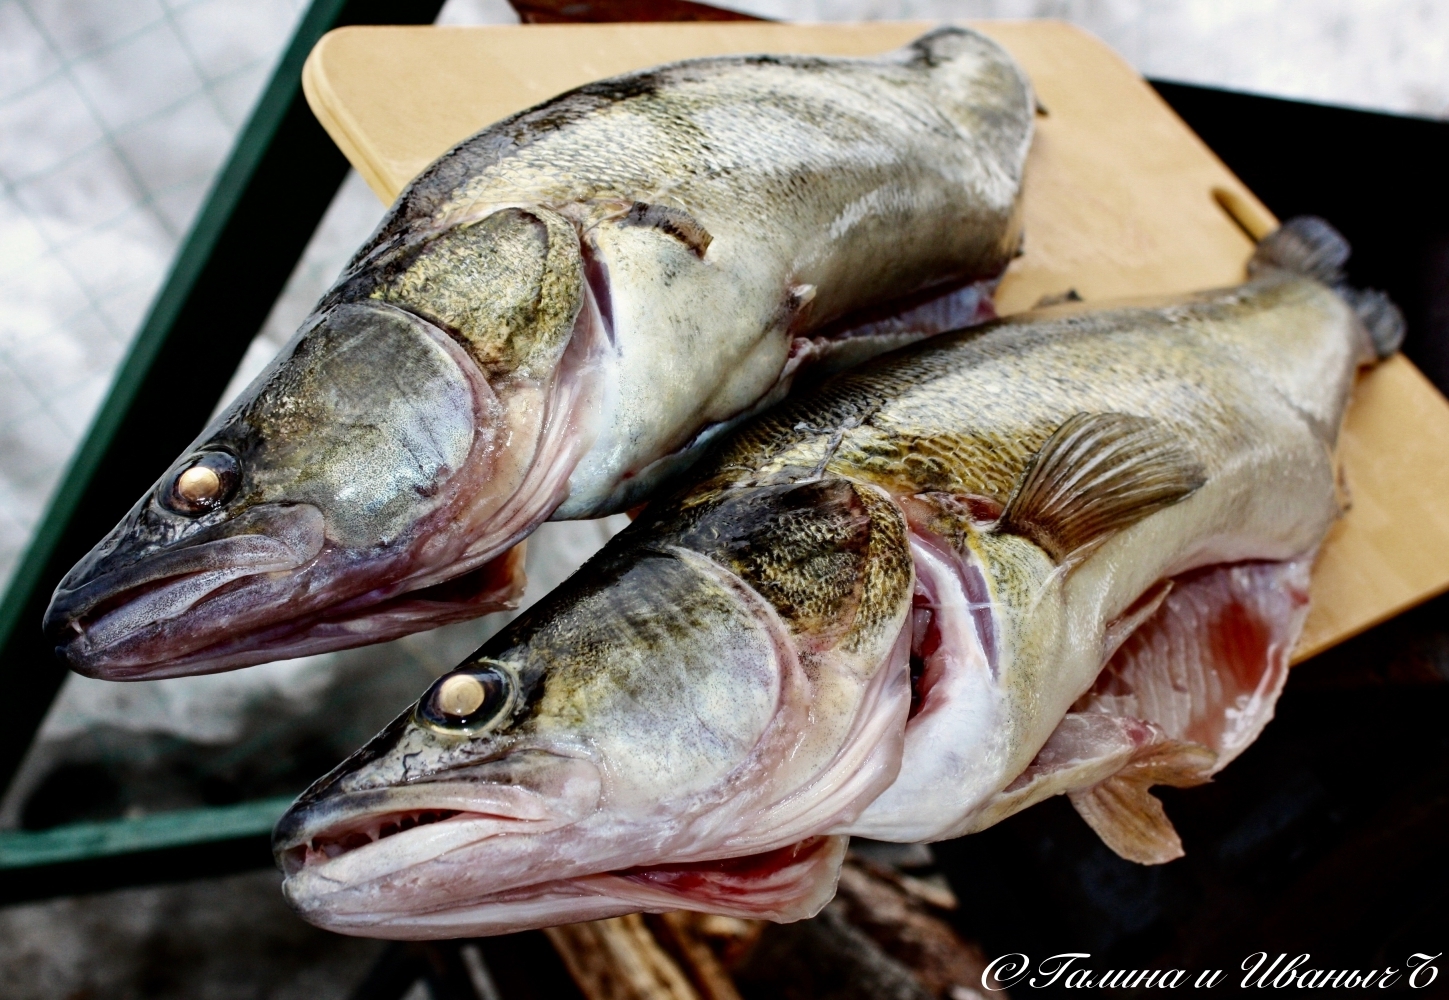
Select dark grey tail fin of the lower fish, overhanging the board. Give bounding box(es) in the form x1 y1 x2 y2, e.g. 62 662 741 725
1248 216 1406 358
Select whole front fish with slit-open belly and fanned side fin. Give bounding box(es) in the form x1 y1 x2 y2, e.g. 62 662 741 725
274 219 1403 938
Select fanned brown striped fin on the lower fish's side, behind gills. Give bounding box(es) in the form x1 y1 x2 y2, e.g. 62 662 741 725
1000 413 1206 562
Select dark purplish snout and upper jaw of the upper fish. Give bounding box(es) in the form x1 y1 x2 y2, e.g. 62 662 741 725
50 504 325 680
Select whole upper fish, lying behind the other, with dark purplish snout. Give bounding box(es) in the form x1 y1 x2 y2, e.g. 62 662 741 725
43 26 1036 680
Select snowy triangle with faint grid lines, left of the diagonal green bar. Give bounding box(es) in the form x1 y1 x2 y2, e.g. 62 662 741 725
0 0 306 583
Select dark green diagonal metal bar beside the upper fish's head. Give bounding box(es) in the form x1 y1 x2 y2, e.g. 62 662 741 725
0 0 442 787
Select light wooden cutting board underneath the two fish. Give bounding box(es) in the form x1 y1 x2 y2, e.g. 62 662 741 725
303 20 1449 659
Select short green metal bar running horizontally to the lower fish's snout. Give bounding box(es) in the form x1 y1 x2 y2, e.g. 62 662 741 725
0 796 293 870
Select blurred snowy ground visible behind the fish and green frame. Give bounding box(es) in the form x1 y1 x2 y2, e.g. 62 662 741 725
0 0 1449 1000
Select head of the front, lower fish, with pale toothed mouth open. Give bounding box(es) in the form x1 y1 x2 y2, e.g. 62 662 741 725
274 475 910 938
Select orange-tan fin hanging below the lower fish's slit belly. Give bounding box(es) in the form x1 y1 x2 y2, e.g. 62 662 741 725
1066 739 1217 865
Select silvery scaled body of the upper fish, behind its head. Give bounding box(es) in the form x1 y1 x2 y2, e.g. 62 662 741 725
325 28 1033 517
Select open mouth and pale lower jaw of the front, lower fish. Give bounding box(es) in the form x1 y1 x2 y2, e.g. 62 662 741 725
277 782 846 939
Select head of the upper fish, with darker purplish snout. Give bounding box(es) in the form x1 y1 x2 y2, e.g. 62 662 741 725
45 209 601 680
